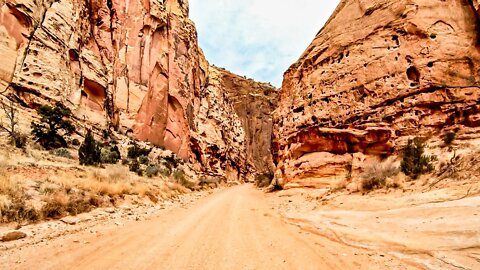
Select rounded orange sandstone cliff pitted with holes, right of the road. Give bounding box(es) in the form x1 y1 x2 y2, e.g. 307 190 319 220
273 0 480 187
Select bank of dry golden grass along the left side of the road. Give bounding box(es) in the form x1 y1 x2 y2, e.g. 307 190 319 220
0 141 195 221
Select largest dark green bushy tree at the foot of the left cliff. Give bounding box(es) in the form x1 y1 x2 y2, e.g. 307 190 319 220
32 102 75 150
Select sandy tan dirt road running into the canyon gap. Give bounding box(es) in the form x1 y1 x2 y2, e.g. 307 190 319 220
1 185 412 269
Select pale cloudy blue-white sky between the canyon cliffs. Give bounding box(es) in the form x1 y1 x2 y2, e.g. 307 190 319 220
190 0 340 87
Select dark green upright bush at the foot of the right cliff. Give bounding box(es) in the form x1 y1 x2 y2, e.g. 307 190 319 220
400 138 437 179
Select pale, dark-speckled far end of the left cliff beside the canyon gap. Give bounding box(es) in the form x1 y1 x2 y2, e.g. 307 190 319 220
192 67 251 181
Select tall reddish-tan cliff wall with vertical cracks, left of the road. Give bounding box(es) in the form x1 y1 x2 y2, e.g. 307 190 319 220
0 0 273 181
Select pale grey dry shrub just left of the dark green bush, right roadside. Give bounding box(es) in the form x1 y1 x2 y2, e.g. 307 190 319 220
361 161 399 191
